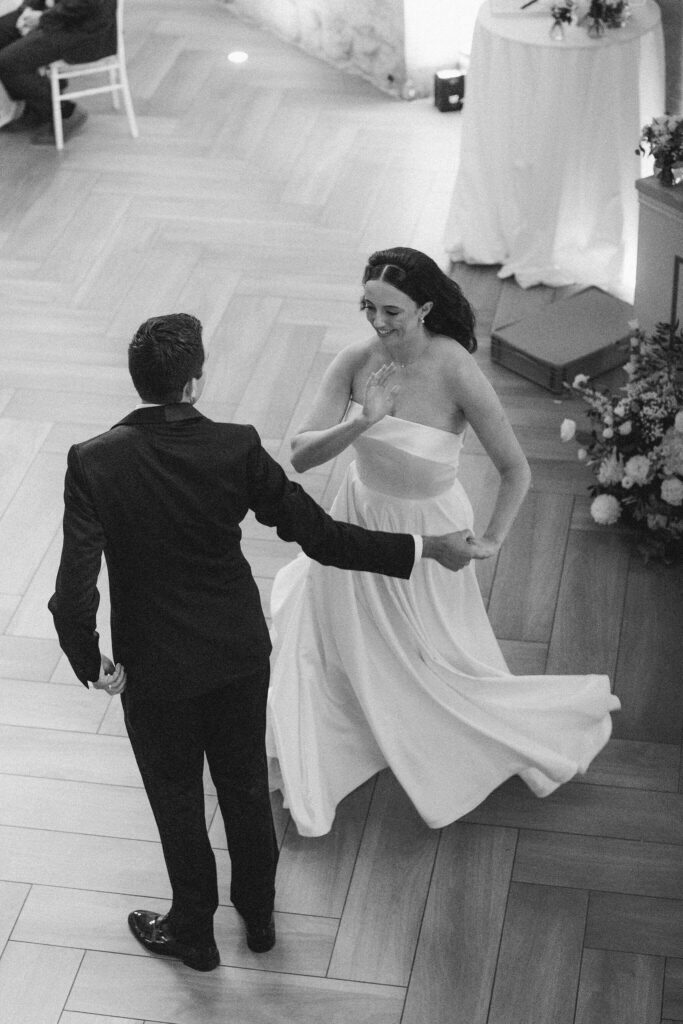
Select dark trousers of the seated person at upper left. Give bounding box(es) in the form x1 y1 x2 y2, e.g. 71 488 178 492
0 10 108 121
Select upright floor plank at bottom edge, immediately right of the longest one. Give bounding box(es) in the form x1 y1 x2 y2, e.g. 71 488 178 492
488 884 588 1024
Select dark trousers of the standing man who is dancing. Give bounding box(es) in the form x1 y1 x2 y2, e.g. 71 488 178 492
122 668 278 946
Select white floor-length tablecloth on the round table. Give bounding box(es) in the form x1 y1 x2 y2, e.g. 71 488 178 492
445 0 665 301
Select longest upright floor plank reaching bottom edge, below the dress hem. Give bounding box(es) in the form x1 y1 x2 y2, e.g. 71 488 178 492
402 824 517 1024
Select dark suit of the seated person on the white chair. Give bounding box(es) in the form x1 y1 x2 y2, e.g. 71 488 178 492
0 0 117 121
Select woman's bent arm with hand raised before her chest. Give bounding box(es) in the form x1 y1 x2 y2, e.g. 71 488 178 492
292 345 396 473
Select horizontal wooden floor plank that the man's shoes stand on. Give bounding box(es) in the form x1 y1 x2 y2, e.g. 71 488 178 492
12 886 338 978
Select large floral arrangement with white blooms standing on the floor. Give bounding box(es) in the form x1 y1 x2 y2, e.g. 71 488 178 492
560 322 683 561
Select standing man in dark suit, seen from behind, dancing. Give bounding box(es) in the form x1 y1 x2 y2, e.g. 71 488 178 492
49 313 481 971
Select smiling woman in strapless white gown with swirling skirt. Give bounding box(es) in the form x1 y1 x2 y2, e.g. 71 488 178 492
267 248 620 836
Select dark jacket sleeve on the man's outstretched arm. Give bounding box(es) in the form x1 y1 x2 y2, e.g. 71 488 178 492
247 428 415 580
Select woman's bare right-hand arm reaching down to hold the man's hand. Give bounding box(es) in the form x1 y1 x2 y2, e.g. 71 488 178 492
454 352 531 555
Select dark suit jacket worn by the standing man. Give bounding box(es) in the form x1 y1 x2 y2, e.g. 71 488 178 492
49 403 415 699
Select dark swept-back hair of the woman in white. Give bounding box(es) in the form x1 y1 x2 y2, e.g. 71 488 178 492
362 246 477 352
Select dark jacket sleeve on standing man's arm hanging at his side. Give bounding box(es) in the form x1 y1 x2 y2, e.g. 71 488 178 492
47 447 104 686
